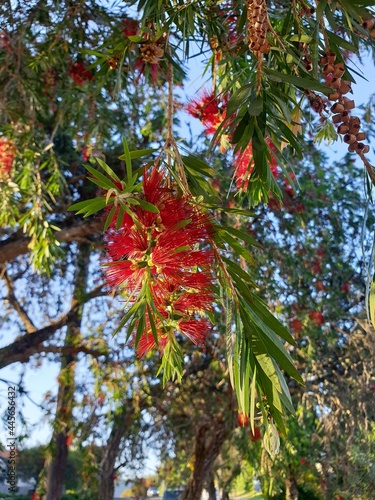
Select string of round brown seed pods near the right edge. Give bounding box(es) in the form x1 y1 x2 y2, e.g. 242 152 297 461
320 52 370 154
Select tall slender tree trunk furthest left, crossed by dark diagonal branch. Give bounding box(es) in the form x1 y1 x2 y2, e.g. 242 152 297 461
44 244 90 500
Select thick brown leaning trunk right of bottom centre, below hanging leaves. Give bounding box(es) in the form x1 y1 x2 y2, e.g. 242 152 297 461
181 421 229 500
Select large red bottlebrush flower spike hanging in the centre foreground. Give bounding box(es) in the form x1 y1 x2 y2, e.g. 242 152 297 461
105 167 214 366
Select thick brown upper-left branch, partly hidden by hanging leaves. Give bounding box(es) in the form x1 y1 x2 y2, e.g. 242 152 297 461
0 219 103 266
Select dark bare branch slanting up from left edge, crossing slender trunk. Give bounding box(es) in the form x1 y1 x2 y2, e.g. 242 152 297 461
0 285 105 368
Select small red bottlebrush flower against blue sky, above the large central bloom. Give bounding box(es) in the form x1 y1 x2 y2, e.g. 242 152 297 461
186 89 225 134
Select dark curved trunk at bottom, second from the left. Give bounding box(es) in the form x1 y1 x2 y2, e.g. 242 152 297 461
99 406 134 500
